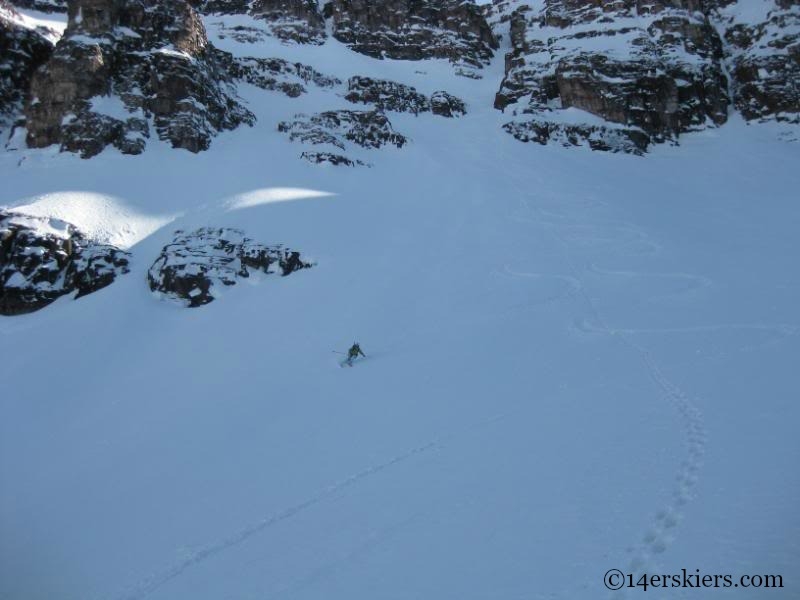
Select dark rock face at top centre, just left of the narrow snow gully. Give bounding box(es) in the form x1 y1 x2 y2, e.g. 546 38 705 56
325 0 498 67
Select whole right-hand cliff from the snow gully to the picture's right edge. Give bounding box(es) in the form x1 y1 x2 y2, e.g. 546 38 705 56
489 0 800 152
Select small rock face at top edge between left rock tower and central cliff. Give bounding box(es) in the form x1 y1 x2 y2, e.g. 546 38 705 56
200 0 326 44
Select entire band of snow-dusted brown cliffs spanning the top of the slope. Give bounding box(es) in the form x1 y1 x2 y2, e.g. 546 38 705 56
0 0 800 157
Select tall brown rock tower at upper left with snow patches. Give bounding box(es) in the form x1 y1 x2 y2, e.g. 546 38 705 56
26 0 254 157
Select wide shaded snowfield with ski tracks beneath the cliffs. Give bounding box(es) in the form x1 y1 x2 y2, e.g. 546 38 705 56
0 8 800 600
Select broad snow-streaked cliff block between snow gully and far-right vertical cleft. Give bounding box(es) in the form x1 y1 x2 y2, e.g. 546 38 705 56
495 0 729 148
